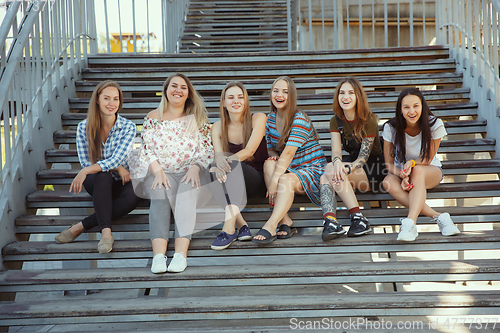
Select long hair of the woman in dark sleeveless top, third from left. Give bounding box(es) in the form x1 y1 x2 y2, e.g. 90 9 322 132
220 81 253 160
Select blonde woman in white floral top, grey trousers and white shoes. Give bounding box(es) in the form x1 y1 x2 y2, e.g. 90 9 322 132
132 73 213 273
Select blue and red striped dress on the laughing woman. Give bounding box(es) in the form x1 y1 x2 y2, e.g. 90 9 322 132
266 111 326 206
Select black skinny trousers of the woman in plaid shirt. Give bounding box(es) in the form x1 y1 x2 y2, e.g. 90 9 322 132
82 172 141 230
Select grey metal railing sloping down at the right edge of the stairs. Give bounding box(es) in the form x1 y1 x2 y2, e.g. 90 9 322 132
436 0 500 116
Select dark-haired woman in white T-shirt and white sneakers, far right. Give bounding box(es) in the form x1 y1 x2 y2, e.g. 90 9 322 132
383 88 460 241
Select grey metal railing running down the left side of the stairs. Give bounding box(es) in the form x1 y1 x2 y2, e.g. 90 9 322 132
0 0 97 262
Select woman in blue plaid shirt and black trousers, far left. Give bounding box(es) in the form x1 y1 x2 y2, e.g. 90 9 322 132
55 80 140 253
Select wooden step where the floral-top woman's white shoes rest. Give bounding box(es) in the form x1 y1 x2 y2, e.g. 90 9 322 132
0 259 500 292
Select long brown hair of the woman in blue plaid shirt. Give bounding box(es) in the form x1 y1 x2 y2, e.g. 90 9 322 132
87 80 123 164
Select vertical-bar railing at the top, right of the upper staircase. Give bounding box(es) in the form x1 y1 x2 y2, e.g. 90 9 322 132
288 0 437 51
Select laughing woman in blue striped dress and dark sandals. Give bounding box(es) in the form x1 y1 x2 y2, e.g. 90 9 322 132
253 76 326 244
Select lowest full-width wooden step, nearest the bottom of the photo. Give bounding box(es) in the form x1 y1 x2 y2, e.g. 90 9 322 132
0 291 500 326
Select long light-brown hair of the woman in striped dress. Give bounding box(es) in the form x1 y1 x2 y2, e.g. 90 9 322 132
270 76 319 150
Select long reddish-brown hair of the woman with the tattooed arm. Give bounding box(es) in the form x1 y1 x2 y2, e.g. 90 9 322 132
333 77 374 142
